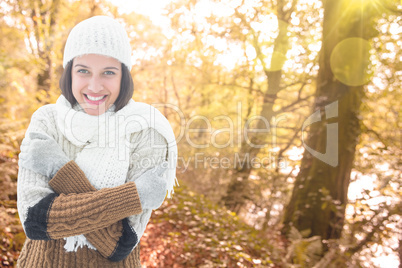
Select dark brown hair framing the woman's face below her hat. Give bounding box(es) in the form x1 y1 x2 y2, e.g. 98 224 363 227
59 60 134 112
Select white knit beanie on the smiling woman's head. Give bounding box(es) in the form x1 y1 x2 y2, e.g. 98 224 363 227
63 16 131 71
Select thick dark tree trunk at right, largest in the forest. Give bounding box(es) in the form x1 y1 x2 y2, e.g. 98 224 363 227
283 0 374 243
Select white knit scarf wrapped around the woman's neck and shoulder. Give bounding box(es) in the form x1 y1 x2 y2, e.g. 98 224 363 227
56 95 178 251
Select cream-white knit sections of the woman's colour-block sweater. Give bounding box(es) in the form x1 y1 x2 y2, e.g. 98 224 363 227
17 104 167 251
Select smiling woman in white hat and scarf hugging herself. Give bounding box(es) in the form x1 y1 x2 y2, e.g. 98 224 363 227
17 16 177 267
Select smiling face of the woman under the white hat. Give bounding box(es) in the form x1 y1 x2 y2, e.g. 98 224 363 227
71 54 122 115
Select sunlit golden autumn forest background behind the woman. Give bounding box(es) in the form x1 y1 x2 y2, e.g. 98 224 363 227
0 0 402 267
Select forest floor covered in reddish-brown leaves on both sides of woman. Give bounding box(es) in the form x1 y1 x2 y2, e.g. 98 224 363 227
0 158 278 268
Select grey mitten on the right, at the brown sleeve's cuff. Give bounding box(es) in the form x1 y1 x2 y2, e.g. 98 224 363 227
135 162 167 209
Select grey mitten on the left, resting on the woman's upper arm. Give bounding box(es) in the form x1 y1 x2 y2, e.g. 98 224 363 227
18 132 70 178
